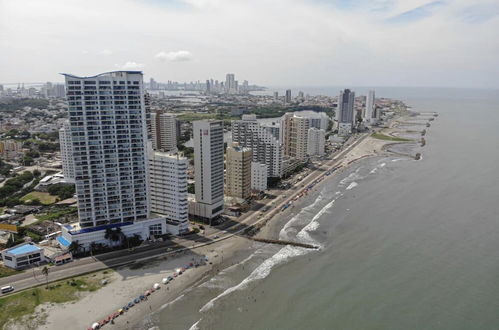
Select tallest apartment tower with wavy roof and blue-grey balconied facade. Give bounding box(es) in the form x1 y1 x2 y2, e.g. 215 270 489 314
64 71 149 228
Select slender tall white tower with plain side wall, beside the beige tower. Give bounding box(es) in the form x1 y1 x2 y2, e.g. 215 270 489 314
189 120 224 219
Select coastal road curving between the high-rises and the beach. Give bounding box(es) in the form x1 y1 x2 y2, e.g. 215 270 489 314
0 134 368 293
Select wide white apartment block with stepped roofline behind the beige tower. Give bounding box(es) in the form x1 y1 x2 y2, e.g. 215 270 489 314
232 115 282 177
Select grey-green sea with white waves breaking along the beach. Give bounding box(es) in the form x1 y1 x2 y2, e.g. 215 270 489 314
143 88 499 330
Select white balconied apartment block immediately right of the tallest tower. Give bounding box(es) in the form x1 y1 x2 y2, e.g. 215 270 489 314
149 151 189 233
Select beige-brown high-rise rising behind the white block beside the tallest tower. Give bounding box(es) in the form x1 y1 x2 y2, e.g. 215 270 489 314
151 111 178 151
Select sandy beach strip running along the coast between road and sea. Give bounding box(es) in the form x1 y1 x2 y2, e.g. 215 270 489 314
8 112 434 329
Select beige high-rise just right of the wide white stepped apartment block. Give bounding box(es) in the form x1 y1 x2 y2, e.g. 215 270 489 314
281 113 310 161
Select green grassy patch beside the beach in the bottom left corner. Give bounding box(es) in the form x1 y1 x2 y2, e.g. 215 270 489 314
0 271 110 329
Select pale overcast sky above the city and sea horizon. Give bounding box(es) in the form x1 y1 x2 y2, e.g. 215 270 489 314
0 0 499 88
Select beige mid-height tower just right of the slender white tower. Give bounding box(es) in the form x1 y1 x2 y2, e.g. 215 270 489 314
225 143 253 199
